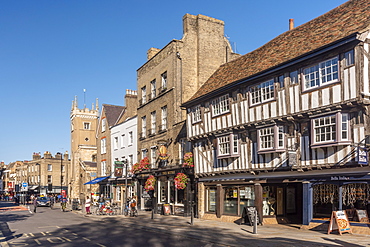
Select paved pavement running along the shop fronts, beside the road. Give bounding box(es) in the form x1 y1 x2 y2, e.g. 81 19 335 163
72 205 370 247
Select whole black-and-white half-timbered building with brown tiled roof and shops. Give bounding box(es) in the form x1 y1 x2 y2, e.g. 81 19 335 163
183 0 370 224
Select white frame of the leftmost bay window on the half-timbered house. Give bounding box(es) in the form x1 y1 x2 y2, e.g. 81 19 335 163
216 133 240 159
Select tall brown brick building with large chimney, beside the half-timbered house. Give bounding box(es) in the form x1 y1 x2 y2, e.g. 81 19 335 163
137 14 238 214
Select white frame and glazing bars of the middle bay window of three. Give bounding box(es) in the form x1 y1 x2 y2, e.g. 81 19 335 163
257 124 287 154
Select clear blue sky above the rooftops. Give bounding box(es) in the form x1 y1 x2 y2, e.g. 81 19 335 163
0 0 346 164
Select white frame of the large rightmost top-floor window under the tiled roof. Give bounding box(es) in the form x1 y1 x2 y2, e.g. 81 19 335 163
302 56 340 91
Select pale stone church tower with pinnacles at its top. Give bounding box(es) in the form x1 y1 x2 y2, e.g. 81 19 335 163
67 96 99 200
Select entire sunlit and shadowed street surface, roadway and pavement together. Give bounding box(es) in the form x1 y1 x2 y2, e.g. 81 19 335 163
0 201 370 247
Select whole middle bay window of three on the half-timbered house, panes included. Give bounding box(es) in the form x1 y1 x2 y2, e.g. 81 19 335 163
257 125 285 153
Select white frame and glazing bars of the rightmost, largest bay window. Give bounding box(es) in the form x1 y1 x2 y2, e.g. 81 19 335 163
311 112 351 148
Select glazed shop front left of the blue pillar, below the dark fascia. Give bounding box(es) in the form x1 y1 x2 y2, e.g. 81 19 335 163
198 179 302 223
